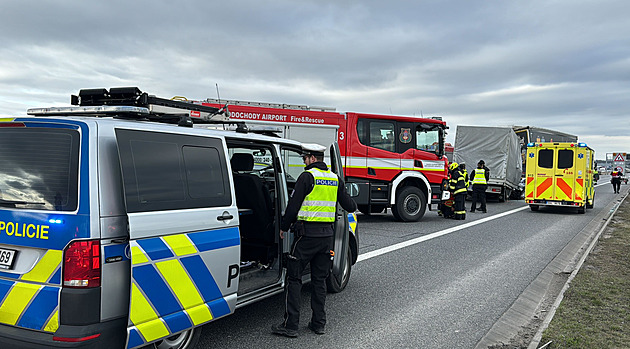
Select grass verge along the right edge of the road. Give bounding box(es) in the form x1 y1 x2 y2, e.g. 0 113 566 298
540 194 630 349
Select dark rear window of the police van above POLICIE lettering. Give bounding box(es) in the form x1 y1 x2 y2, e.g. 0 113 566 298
0 127 80 211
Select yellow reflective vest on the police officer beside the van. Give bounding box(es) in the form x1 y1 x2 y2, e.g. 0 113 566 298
298 168 339 222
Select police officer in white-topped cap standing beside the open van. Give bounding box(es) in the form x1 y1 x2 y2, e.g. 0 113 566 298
271 144 357 337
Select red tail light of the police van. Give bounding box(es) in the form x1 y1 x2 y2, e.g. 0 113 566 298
63 240 101 288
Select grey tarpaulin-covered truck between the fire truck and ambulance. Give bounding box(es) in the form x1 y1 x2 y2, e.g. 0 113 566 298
453 125 522 201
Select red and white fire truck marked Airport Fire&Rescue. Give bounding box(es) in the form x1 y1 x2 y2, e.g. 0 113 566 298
200 98 448 222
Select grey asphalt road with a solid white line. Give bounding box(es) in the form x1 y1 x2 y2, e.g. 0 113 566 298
198 176 627 348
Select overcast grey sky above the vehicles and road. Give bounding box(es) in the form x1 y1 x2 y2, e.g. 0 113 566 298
0 0 630 159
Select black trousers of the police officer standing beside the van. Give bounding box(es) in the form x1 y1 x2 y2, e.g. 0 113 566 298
284 236 333 330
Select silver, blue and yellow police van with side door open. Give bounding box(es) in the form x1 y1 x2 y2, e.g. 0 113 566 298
0 88 358 348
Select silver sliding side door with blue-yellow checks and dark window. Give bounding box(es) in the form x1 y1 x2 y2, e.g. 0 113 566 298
116 129 240 348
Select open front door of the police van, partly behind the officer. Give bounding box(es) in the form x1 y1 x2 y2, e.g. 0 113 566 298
329 142 350 285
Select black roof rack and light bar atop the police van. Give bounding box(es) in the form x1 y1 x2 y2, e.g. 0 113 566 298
27 87 247 132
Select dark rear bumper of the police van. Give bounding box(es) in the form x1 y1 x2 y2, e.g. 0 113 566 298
0 318 127 349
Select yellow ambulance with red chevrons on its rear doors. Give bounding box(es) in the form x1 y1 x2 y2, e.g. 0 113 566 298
525 142 595 213
